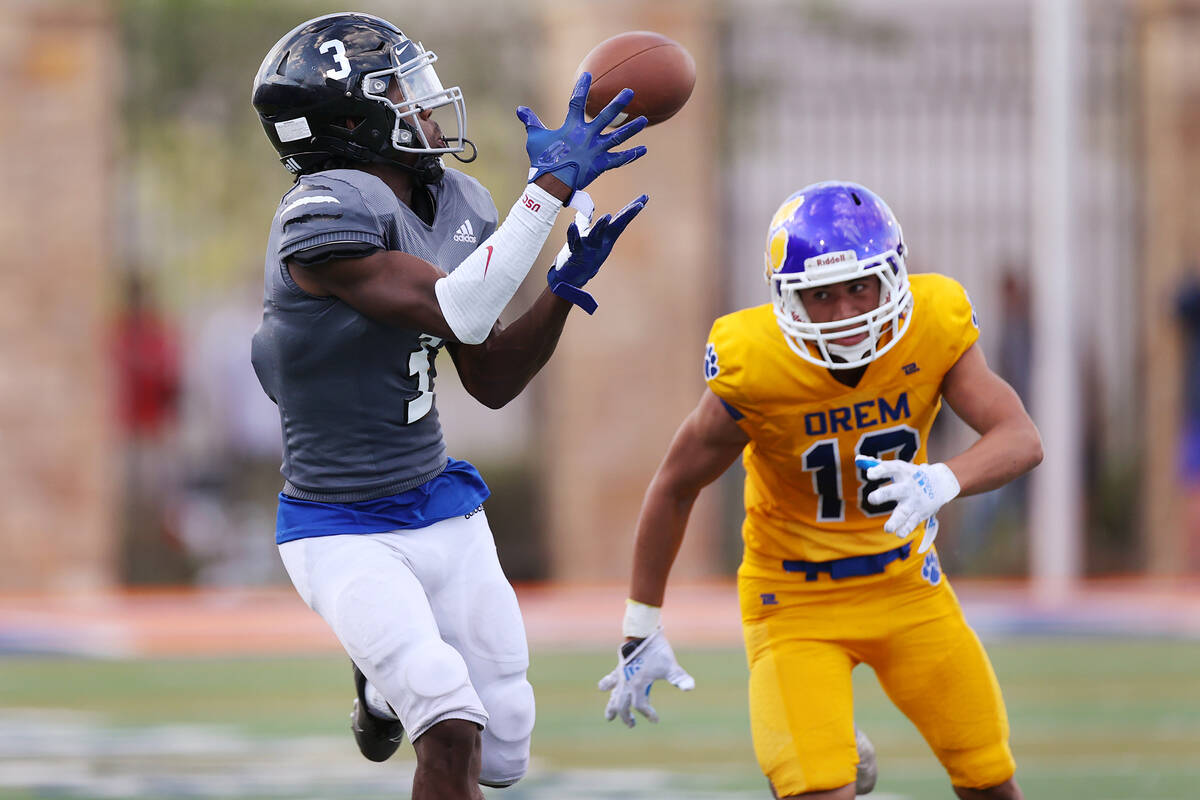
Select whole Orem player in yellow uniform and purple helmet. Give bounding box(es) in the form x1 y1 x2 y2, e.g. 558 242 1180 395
600 182 1042 800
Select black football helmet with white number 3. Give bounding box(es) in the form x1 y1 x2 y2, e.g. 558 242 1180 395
252 12 475 184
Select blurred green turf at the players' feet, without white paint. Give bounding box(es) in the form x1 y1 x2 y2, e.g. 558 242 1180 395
0 638 1200 800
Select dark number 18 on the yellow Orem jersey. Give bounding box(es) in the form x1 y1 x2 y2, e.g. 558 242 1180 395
800 425 920 522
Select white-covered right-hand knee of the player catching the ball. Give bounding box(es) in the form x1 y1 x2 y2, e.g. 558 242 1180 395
479 673 536 787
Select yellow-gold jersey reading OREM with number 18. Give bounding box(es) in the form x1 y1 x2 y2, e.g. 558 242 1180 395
704 273 979 561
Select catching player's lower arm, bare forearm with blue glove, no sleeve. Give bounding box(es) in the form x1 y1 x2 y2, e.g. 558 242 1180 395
449 194 648 408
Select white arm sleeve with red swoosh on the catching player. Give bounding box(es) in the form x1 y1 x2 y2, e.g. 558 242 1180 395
433 184 563 344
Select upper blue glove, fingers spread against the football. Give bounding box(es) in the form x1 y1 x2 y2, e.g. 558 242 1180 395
517 72 646 192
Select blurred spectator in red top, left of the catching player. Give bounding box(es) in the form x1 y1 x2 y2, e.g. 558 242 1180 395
112 272 188 584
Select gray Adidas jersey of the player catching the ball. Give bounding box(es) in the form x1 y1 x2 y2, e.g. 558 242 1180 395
252 169 498 503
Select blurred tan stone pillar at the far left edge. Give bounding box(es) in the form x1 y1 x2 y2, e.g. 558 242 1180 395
0 0 119 591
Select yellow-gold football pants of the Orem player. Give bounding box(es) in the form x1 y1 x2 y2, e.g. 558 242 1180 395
738 547 1015 798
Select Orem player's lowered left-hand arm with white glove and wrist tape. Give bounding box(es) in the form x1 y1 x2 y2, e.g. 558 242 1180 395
599 391 750 728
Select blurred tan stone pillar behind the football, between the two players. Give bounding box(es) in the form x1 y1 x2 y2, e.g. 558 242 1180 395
542 0 724 585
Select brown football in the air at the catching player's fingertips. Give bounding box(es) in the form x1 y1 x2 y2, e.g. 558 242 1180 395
576 30 696 125
